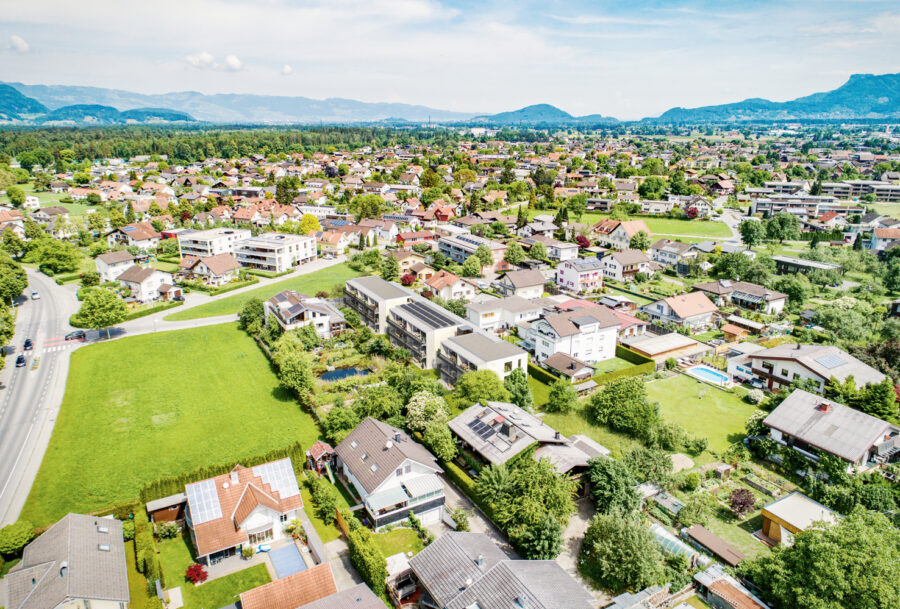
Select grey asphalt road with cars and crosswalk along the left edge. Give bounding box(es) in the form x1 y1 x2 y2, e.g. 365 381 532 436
0 270 78 524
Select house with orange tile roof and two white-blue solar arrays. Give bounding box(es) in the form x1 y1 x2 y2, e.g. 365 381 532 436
184 458 303 565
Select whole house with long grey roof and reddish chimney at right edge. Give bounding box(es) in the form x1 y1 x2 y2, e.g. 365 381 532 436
763 389 900 471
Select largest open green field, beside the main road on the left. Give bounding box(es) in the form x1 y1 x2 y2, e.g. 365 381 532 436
22 324 319 526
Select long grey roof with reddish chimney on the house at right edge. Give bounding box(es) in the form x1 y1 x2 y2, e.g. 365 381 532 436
763 389 897 462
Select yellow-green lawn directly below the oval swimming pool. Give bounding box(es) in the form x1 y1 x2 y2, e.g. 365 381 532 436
647 374 756 452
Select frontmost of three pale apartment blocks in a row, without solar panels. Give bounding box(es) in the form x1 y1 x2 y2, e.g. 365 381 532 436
436 332 528 386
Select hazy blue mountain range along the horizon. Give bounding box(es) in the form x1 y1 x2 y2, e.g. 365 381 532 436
0 74 900 127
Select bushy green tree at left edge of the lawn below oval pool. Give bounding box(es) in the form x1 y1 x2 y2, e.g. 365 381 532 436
587 377 659 438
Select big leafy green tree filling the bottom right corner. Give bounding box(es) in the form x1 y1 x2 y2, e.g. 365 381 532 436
738 508 900 609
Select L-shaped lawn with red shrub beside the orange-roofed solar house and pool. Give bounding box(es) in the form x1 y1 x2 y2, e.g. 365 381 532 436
159 537 271 609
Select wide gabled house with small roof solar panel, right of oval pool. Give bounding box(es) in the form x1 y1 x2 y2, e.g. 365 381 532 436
749 343 885 392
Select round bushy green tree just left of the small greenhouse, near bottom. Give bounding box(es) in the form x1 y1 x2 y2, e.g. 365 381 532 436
578 513 665 592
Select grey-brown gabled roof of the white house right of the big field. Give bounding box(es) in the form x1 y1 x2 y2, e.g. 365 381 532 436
334 417 444 493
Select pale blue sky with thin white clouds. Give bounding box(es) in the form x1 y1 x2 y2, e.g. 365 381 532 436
0 0 900 120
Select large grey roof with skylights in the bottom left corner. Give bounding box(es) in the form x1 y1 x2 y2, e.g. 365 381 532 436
5 514 129 609
